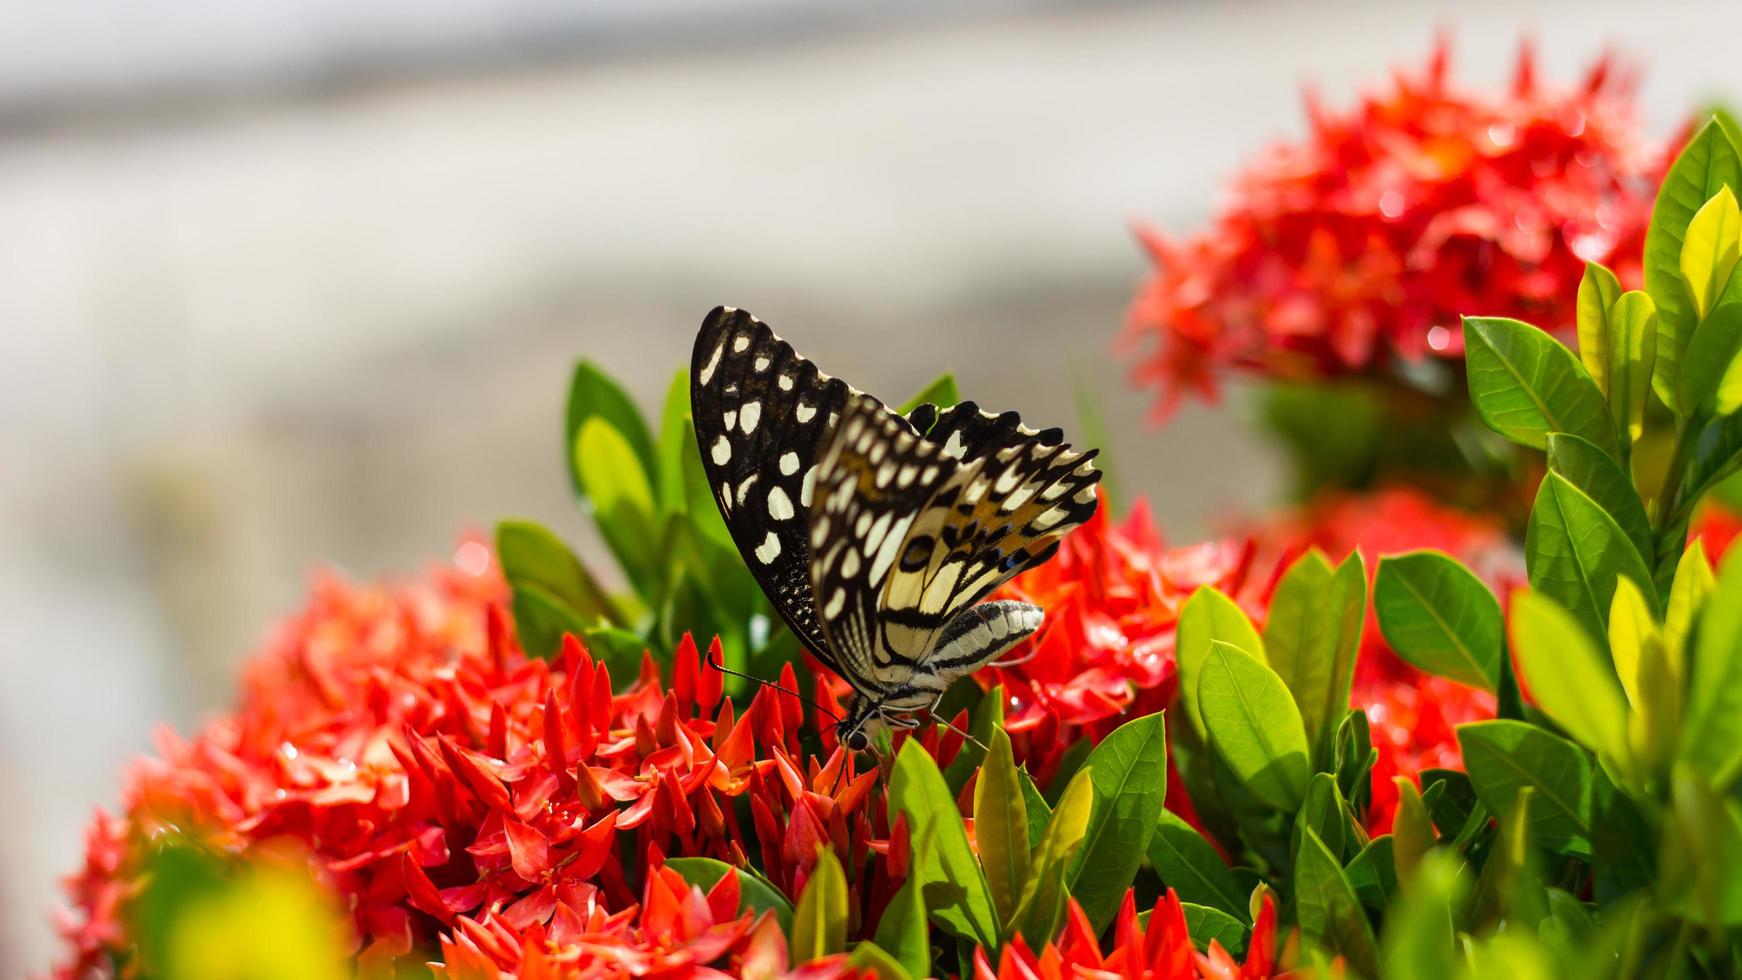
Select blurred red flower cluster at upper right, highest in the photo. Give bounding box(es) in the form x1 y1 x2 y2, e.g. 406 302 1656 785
1125 42 1667 418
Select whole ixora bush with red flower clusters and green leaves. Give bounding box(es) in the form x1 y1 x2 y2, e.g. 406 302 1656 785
44 42 1742 980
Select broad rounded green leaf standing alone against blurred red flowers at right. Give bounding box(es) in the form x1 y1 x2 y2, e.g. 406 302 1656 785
1373 550 1498 691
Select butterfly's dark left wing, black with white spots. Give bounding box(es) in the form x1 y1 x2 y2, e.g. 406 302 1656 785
690 306 908 672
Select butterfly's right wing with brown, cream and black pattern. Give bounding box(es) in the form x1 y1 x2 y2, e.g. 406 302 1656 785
810 399 1101 695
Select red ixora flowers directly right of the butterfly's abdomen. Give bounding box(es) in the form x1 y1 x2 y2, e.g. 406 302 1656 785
977 500 1252 785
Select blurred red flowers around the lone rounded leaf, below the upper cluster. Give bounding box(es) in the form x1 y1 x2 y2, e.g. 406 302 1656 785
1251 487 1524 834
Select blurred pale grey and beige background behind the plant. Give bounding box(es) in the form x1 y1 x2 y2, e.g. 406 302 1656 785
0 0 1742 977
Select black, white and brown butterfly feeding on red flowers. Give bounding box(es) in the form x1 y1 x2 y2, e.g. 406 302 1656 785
690 306 1101 750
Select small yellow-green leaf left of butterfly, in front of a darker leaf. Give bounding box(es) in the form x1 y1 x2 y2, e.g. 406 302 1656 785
575 418 660 595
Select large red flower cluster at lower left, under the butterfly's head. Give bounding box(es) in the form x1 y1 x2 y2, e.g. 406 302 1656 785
52 543 884 977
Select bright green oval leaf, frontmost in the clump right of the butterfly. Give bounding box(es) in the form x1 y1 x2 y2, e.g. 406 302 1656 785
1198 641 1312 813
